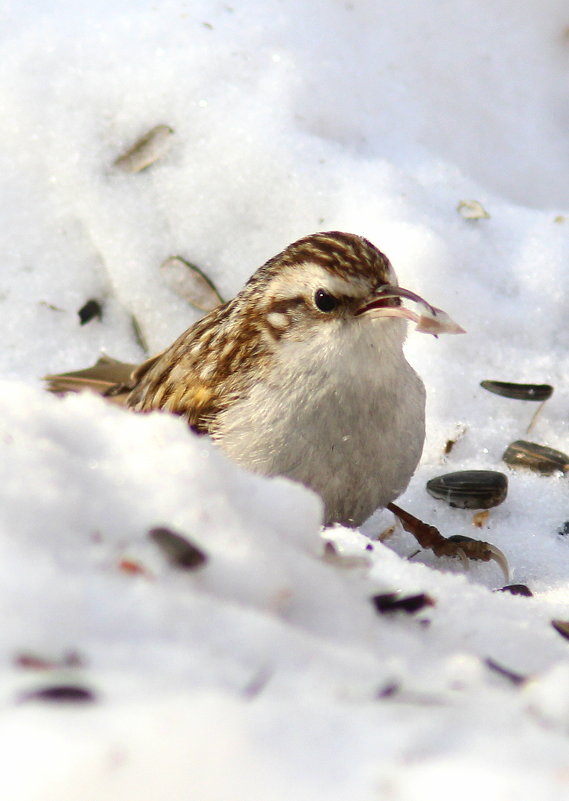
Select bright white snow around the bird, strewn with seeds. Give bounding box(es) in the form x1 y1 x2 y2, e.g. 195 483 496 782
0 0 569 801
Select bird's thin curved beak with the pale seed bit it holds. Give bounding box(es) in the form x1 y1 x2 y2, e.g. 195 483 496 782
357 284 465 336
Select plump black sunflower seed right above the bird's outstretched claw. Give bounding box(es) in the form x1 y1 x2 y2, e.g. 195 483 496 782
427 470 508 509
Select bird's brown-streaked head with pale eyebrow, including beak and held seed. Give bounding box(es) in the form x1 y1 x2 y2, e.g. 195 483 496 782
243 231 463 341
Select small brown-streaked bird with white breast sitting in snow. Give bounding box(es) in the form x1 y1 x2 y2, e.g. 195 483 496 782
46 231 506 558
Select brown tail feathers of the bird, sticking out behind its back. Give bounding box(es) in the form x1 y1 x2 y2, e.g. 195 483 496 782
44 355 137 406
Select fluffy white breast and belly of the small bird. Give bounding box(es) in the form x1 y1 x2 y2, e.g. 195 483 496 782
216 320 425 526
